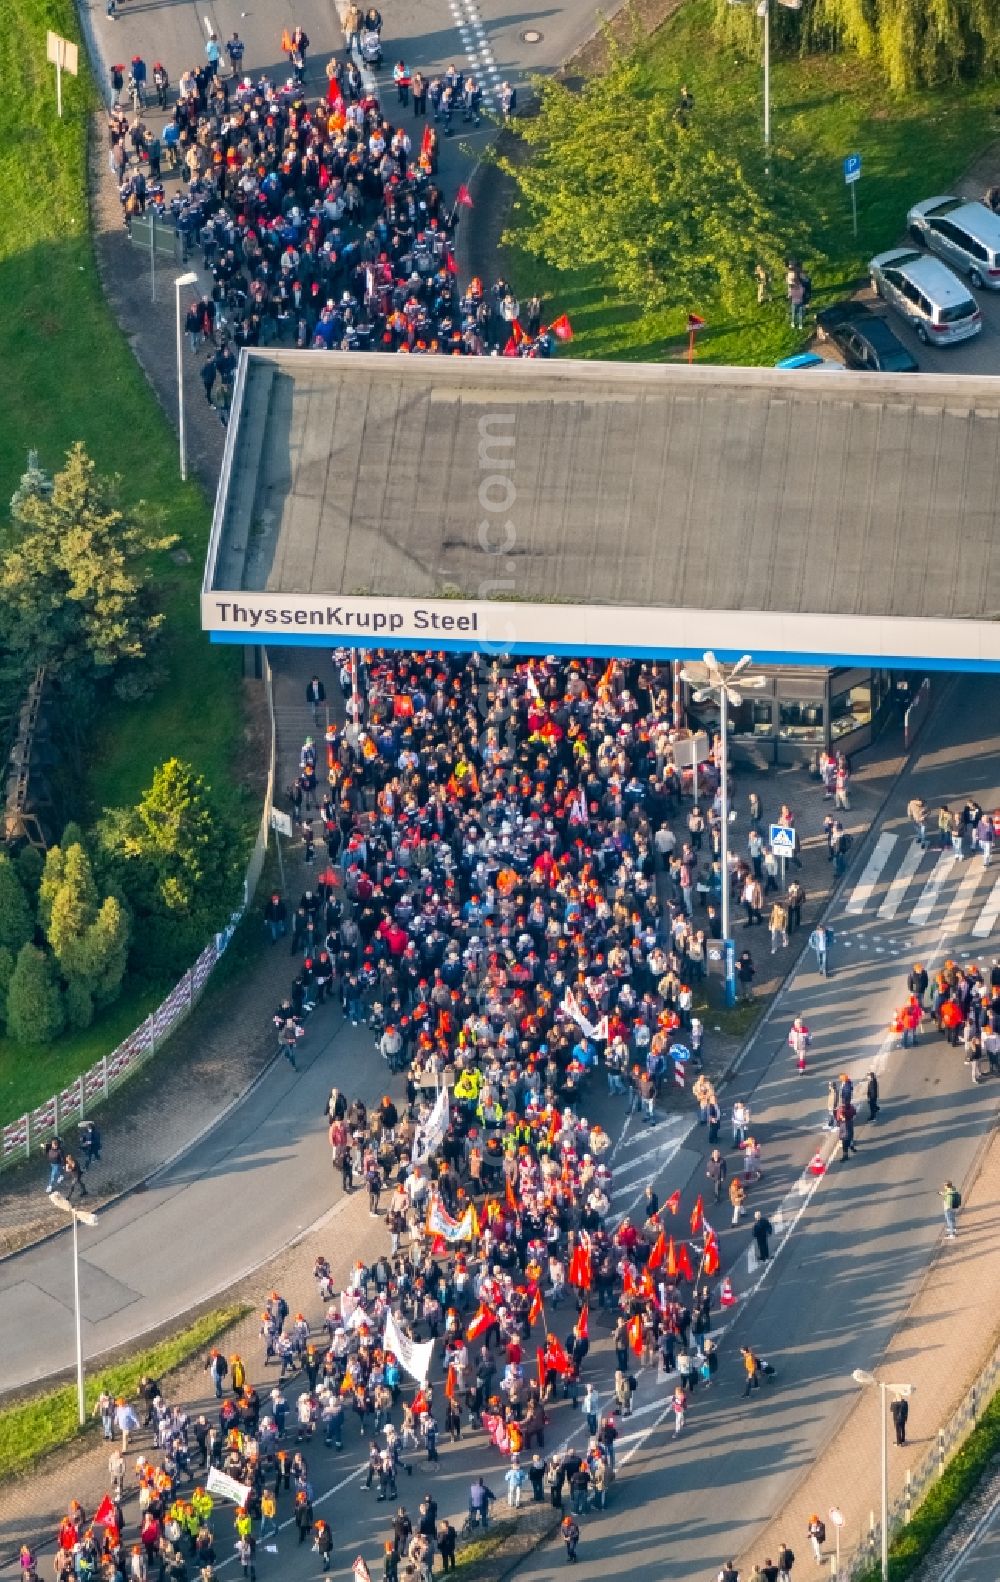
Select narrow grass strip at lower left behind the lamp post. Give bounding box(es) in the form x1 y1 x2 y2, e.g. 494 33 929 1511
0 1305 250 1482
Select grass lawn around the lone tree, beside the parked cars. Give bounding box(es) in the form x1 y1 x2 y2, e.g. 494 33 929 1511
505 0 1000 364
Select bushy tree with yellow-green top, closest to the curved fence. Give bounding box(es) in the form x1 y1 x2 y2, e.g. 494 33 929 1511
98 758 237 976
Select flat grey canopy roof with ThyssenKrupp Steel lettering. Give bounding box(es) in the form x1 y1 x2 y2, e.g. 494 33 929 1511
203 351 1000 668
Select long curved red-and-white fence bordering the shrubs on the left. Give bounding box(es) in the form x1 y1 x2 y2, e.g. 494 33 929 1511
0 652 275 1169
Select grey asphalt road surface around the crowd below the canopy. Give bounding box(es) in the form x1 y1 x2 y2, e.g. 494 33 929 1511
0 679 1000 1579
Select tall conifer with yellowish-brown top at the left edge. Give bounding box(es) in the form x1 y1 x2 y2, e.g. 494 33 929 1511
0 445 172 680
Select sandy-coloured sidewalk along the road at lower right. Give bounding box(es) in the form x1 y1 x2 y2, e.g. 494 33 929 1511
723 1107 1000 1576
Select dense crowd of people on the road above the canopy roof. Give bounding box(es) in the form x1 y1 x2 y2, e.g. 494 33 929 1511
109 8 571 421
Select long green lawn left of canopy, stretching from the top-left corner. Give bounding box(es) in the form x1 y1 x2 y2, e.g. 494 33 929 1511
0 0 248 823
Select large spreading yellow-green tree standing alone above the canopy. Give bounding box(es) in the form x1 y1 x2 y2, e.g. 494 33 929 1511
500 49 807 310
